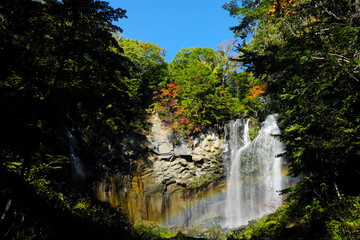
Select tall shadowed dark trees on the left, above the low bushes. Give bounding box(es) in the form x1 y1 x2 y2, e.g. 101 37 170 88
0 0 142 180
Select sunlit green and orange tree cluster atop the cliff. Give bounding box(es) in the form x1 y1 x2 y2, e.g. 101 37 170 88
153 43 267 135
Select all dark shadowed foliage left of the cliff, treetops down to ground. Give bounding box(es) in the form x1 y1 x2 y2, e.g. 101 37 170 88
0 0 151 239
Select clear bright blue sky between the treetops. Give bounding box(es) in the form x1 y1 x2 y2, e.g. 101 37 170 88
108 0 237 62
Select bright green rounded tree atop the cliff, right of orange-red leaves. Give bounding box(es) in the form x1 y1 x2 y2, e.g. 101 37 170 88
169 47 239 132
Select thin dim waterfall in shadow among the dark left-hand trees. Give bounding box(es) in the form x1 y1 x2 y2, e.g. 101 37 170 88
66 131 85 185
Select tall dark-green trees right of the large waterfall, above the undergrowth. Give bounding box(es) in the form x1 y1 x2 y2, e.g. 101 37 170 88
225 0 360 196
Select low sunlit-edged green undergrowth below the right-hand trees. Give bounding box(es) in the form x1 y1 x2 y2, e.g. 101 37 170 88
228 197 360 240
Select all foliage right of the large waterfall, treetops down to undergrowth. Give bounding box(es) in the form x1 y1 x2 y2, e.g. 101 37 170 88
225 0 360 239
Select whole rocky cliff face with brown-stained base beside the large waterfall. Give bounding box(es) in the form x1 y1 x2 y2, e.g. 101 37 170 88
96 115 224 226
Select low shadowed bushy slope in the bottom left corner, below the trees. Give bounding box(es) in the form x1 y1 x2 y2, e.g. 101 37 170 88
0 168 138 240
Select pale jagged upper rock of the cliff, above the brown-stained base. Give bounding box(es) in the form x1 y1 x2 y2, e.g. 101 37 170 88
148 115 224 188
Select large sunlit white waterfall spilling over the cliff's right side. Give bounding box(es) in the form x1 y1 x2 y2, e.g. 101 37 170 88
223 115 284 228
